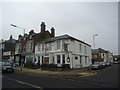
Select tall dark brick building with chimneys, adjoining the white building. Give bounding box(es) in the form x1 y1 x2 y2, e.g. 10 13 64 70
15 22 55 64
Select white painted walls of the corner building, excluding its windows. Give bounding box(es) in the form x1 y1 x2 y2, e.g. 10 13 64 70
35 39 91 68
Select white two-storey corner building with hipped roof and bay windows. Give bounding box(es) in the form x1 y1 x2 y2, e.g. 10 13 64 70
35 35 91 68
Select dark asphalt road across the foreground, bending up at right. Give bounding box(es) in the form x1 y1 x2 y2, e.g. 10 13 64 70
2 64 118 89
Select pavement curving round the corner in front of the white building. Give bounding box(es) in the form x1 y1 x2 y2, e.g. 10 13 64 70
15 67 97 78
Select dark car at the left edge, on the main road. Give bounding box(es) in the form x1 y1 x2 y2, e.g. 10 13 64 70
2 62 14 73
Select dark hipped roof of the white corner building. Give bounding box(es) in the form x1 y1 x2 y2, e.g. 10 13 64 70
39 34 91 46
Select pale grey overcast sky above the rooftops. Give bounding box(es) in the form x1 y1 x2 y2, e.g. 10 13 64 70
0 2 118 54
